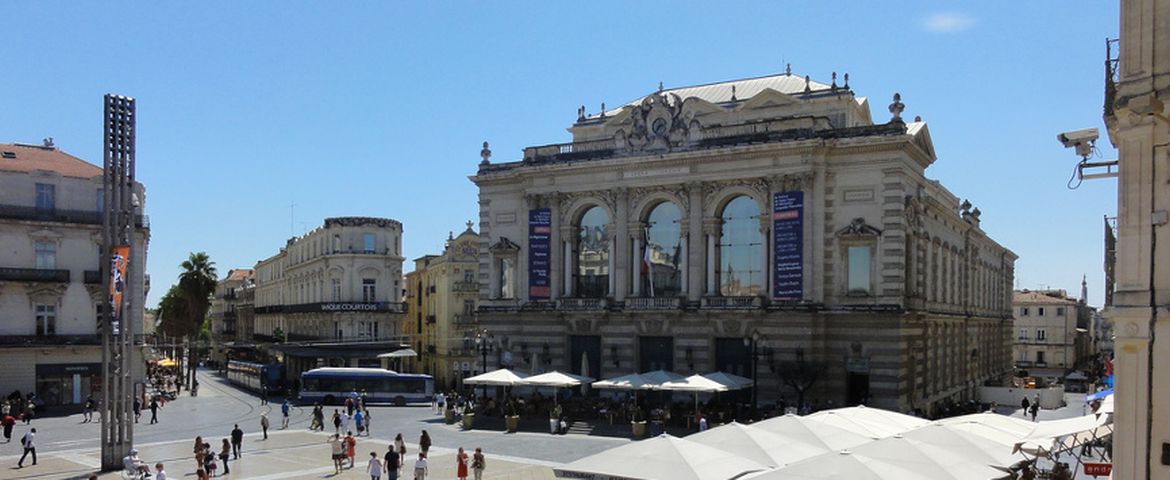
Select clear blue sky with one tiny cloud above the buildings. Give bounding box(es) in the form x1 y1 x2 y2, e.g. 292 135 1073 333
0 1 1117 306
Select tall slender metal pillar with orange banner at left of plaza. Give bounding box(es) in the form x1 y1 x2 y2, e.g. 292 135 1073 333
98 95 136 471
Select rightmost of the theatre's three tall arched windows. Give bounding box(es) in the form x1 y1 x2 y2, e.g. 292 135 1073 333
717 196 764 296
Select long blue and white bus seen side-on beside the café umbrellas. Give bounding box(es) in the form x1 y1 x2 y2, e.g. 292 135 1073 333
300 368 434 405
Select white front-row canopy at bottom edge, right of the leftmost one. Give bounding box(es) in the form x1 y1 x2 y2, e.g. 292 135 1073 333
748 436 1009 480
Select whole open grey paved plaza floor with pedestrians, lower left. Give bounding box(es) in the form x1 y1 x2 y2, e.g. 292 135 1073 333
0 372 629 480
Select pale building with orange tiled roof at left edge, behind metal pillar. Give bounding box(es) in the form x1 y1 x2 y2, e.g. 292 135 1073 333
0 140 150 405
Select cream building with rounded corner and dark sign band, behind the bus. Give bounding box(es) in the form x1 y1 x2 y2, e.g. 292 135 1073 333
253 217 402 379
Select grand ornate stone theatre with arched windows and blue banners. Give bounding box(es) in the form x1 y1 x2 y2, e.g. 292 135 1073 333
470 73 1016 411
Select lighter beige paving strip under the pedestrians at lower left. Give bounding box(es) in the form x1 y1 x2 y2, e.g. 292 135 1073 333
0 431 555 480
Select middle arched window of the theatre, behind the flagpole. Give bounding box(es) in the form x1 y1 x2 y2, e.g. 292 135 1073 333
640 201 686 296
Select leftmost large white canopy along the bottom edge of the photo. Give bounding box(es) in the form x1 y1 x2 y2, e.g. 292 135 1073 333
552 434 768 480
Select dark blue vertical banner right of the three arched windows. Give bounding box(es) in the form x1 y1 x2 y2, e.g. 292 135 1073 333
772 192 804 300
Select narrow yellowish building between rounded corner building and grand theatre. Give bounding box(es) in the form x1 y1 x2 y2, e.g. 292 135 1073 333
402 221 483 389
